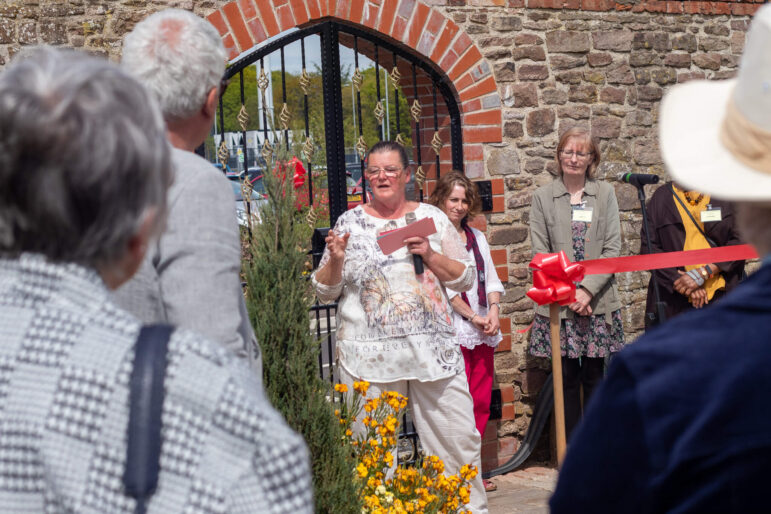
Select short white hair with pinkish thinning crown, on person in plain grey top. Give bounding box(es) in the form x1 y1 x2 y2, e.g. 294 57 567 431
121 9 226 120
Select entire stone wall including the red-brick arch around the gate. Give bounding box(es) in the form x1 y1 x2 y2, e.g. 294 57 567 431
0 0 758 468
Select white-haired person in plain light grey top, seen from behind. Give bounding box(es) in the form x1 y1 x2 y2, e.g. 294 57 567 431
116 9 262 368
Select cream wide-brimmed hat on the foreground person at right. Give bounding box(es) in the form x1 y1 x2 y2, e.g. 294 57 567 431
659 5 771 201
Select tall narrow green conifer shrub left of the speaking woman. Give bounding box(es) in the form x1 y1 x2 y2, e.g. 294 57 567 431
244 155 361 514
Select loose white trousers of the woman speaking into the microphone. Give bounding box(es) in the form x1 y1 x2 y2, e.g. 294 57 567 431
339 366 487 514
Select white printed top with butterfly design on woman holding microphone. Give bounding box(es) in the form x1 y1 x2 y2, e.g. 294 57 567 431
312 203 476 382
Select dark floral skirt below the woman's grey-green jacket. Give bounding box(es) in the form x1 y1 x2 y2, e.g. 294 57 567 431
529 309 624 359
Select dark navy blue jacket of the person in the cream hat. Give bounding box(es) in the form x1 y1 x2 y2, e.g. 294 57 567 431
550 264 771 513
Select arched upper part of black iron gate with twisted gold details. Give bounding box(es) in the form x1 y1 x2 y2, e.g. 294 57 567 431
214 21 463 226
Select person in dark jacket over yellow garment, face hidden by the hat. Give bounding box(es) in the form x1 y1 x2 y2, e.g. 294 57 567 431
640 182 744 329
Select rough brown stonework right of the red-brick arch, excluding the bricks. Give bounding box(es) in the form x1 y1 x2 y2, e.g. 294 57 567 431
446 7 749 466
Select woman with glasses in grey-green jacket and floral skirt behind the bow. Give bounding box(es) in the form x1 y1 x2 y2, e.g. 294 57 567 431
530 128 624 437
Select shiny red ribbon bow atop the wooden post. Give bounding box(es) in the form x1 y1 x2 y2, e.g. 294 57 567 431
527 252 584 305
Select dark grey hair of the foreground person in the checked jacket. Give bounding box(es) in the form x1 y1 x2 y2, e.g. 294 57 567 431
0 47 172 270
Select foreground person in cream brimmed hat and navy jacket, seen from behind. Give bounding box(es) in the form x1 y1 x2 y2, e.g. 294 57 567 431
551 6 771 513
